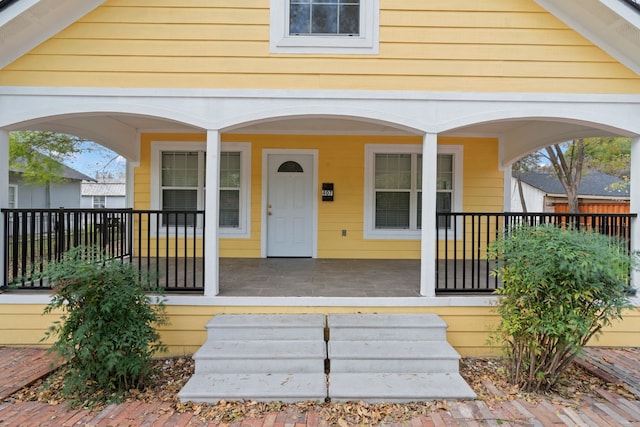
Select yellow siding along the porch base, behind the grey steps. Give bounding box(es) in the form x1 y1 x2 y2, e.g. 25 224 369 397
0 304 640 356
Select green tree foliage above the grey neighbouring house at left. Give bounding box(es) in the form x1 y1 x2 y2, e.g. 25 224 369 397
9 131 86 185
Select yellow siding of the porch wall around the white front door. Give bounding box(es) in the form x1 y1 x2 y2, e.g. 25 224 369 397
139 134 503 259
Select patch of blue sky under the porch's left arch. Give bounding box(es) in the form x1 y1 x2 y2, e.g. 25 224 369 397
64 142 125 178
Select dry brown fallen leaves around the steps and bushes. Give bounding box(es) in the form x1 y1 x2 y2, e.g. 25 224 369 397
5 357 632 427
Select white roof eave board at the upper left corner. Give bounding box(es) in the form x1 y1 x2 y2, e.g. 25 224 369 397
0 0 105 68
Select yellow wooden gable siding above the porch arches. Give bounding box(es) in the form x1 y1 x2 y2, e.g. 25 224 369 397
0 0 640 93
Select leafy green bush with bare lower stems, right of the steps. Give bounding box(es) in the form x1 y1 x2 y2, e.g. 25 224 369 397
489 226 636 391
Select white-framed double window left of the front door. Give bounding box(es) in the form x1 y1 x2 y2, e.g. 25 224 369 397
151 142 251 237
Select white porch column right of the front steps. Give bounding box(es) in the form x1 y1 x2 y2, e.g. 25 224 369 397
420 133 438 297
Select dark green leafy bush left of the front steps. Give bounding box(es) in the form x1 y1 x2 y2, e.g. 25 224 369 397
44 247 166 403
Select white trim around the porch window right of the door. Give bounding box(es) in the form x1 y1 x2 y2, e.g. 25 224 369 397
364 144 463 240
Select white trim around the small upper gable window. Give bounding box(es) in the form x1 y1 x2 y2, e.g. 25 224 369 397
269 0 380 55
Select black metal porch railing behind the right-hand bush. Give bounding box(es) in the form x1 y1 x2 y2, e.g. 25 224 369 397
436 212 637 294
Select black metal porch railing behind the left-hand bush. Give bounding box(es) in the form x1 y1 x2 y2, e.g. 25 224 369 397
0 209 204 292
